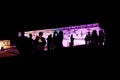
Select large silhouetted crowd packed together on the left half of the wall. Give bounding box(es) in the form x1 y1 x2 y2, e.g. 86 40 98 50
16 31 63 55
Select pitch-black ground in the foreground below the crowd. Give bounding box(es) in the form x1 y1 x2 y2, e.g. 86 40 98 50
0 46 120 80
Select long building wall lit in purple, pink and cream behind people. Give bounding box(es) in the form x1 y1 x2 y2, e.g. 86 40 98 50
19 23 104 47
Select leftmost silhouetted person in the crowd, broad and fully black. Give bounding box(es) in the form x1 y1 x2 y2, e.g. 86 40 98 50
16 31 29 55
